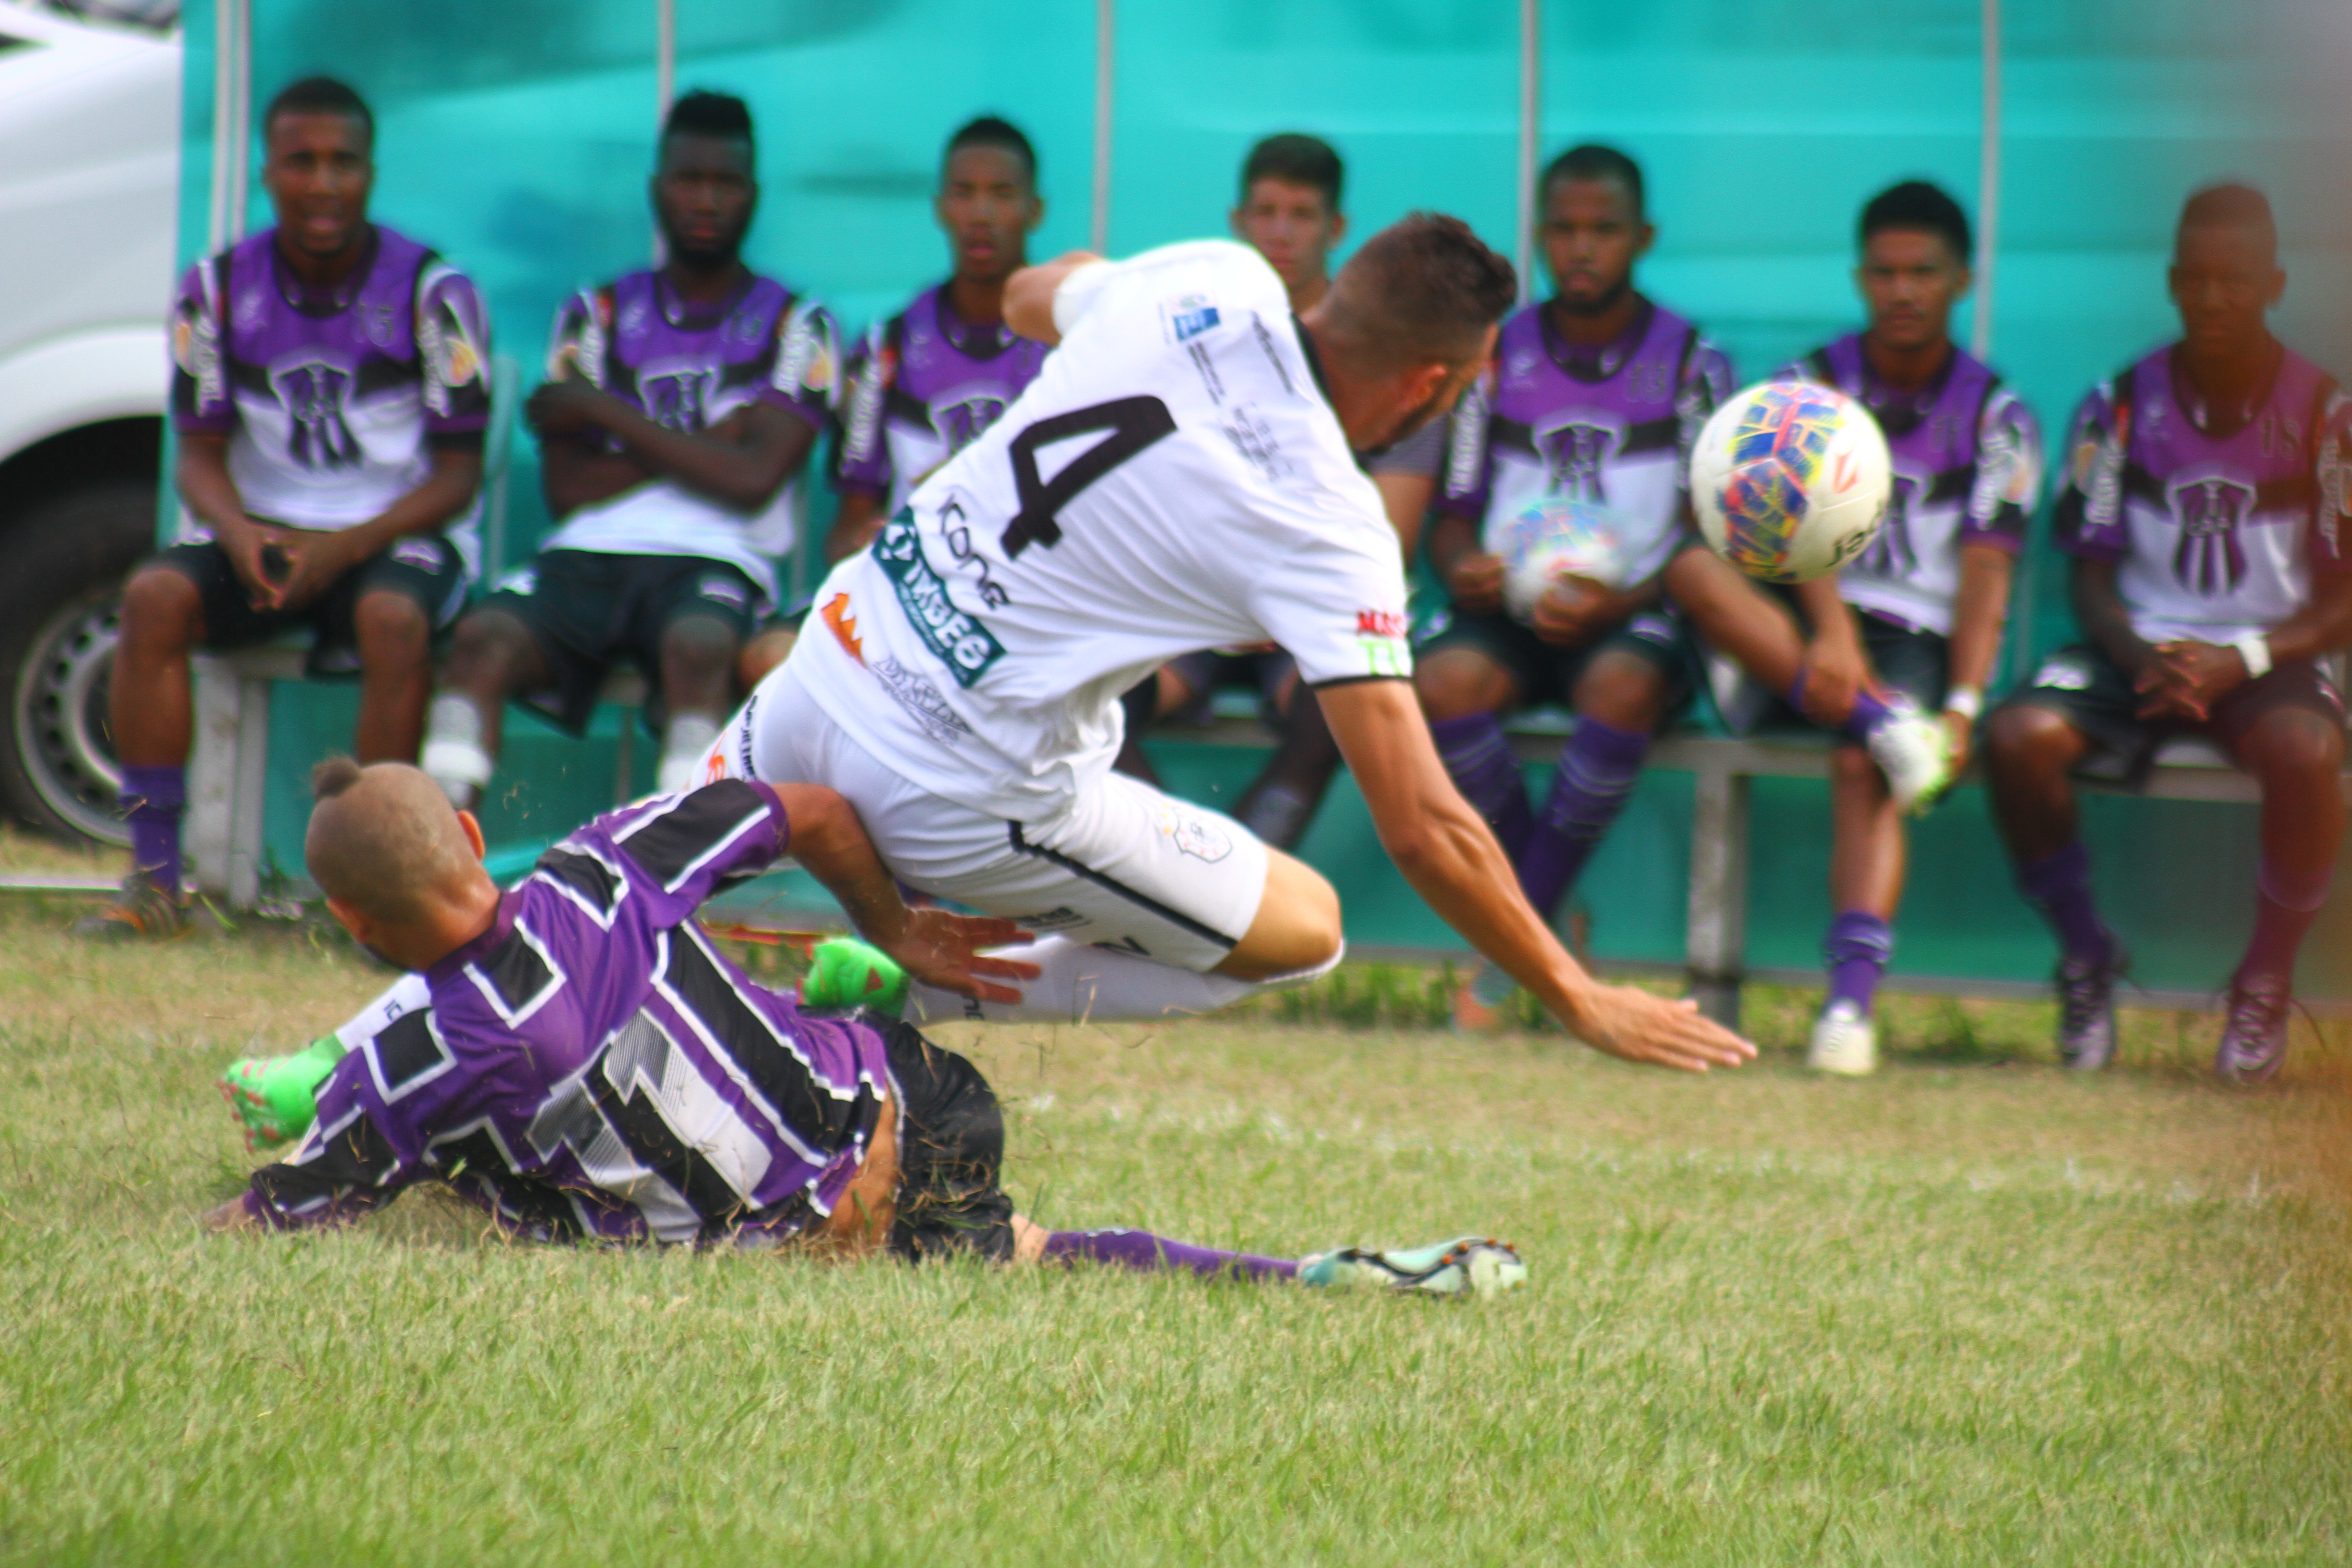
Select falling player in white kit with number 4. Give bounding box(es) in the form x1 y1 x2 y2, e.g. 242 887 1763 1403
706 214 1752 1070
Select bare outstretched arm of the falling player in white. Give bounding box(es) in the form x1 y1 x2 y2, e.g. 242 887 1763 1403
1317 679 1754 1072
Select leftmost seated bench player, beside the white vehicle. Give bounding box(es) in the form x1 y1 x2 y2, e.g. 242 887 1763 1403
80 78 489 936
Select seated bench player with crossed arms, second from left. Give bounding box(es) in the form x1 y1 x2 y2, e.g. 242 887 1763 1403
423 92 840 806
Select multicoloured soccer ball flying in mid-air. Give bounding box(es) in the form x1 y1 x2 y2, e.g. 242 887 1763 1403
1691 381 1893 583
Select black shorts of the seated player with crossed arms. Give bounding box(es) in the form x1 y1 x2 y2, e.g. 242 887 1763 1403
482 550 767 736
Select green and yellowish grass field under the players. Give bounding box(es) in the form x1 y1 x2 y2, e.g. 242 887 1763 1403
0 841 2352 1568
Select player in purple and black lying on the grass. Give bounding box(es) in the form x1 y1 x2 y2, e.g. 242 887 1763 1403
205 757 1524 1293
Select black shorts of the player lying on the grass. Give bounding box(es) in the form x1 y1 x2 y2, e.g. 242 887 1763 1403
856 1013 1014 1262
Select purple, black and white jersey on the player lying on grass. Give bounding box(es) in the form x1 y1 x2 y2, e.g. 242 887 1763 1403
245 780 889 1246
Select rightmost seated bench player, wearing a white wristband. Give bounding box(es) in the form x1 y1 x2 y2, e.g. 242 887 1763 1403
1985 186 2352 1081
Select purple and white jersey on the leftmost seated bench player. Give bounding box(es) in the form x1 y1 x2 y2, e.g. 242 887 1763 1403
172 223 489 567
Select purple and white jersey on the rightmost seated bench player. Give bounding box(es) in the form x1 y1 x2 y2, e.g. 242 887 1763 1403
2056 346 2352 642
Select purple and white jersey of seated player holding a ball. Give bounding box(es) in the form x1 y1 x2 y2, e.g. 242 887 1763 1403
1440 299 1731 581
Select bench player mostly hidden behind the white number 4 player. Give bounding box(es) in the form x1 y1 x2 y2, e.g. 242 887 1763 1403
1120 132 1446 848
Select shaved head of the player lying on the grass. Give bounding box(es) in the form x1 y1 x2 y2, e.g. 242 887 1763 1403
301 757 487 926
